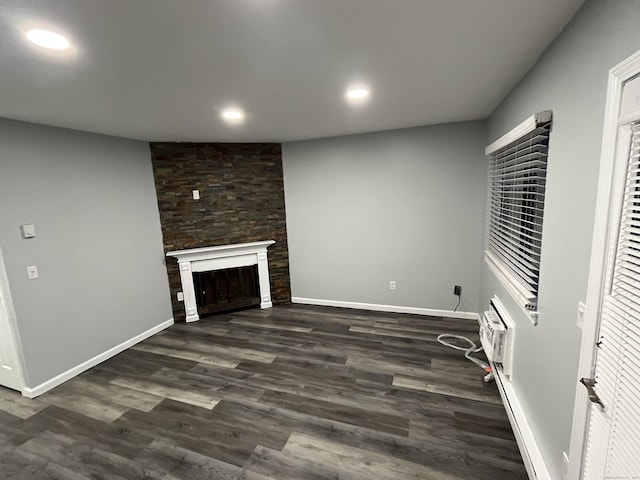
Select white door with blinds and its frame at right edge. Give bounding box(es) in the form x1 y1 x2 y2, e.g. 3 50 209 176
568 52 640 480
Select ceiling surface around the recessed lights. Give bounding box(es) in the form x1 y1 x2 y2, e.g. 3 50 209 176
0 0 584 142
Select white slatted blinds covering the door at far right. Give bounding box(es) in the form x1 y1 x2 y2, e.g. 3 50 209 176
585 124 640 478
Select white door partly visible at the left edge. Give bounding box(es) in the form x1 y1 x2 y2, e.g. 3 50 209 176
0 246 24 390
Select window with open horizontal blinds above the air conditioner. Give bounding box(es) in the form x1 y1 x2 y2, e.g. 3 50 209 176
485 111 551 323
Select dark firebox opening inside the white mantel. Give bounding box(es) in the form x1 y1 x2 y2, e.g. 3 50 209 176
193 265 260 316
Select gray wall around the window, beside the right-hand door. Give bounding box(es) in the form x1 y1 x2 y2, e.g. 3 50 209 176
481 0 640 478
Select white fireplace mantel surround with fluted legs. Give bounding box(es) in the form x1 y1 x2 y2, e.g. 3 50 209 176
167 240 276 322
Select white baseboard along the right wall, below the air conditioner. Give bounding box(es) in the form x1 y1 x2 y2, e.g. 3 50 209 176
491 364 552 480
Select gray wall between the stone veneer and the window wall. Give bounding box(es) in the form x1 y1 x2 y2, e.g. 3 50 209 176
282 122 486 311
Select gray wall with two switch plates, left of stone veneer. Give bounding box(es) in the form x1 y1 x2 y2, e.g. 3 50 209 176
0 119 172 387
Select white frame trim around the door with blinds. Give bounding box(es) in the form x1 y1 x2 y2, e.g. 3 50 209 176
567 51 640 480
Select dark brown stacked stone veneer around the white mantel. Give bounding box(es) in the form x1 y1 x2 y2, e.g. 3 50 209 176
151 143 291 321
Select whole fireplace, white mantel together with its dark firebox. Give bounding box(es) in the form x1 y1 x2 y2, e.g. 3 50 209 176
167 240 275 322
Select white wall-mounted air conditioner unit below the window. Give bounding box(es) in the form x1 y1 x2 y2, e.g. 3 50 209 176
480 295 516 378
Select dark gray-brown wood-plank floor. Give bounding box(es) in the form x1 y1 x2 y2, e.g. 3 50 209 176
0 305 527 480
